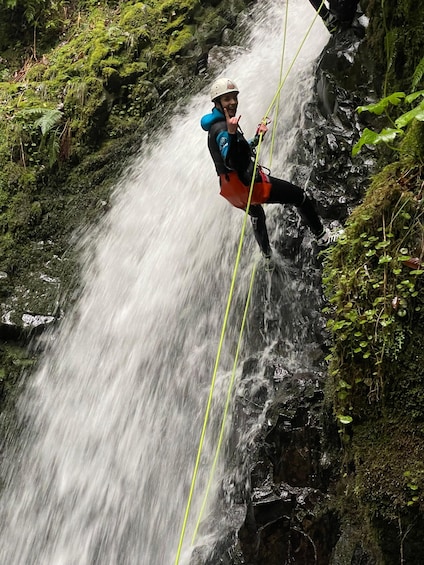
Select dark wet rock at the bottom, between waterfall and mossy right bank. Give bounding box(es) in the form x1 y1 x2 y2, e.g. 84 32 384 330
190 359 340 565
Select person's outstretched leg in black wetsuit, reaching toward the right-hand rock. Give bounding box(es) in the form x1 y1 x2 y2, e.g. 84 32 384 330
267 177 324 236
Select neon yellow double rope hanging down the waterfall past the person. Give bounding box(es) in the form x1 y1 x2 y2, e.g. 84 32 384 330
175 0 324 565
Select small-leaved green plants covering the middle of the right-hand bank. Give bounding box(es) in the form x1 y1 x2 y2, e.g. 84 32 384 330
323 187 424 425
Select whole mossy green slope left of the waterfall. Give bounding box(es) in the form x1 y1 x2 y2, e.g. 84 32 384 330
0 0 247 420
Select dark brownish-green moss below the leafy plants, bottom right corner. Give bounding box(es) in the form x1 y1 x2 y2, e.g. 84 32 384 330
333 418 424 565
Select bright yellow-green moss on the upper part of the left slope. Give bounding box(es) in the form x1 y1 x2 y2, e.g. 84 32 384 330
0 0 242 184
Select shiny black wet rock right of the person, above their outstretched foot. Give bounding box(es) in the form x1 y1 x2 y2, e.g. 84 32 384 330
296 26 375 223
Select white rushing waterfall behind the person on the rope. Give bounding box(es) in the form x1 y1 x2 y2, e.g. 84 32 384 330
0 0 327 565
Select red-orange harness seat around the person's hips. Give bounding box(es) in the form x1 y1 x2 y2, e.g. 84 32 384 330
219 168 271 210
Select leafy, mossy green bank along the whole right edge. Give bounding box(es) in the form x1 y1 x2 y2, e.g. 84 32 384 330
323 0 424 565
